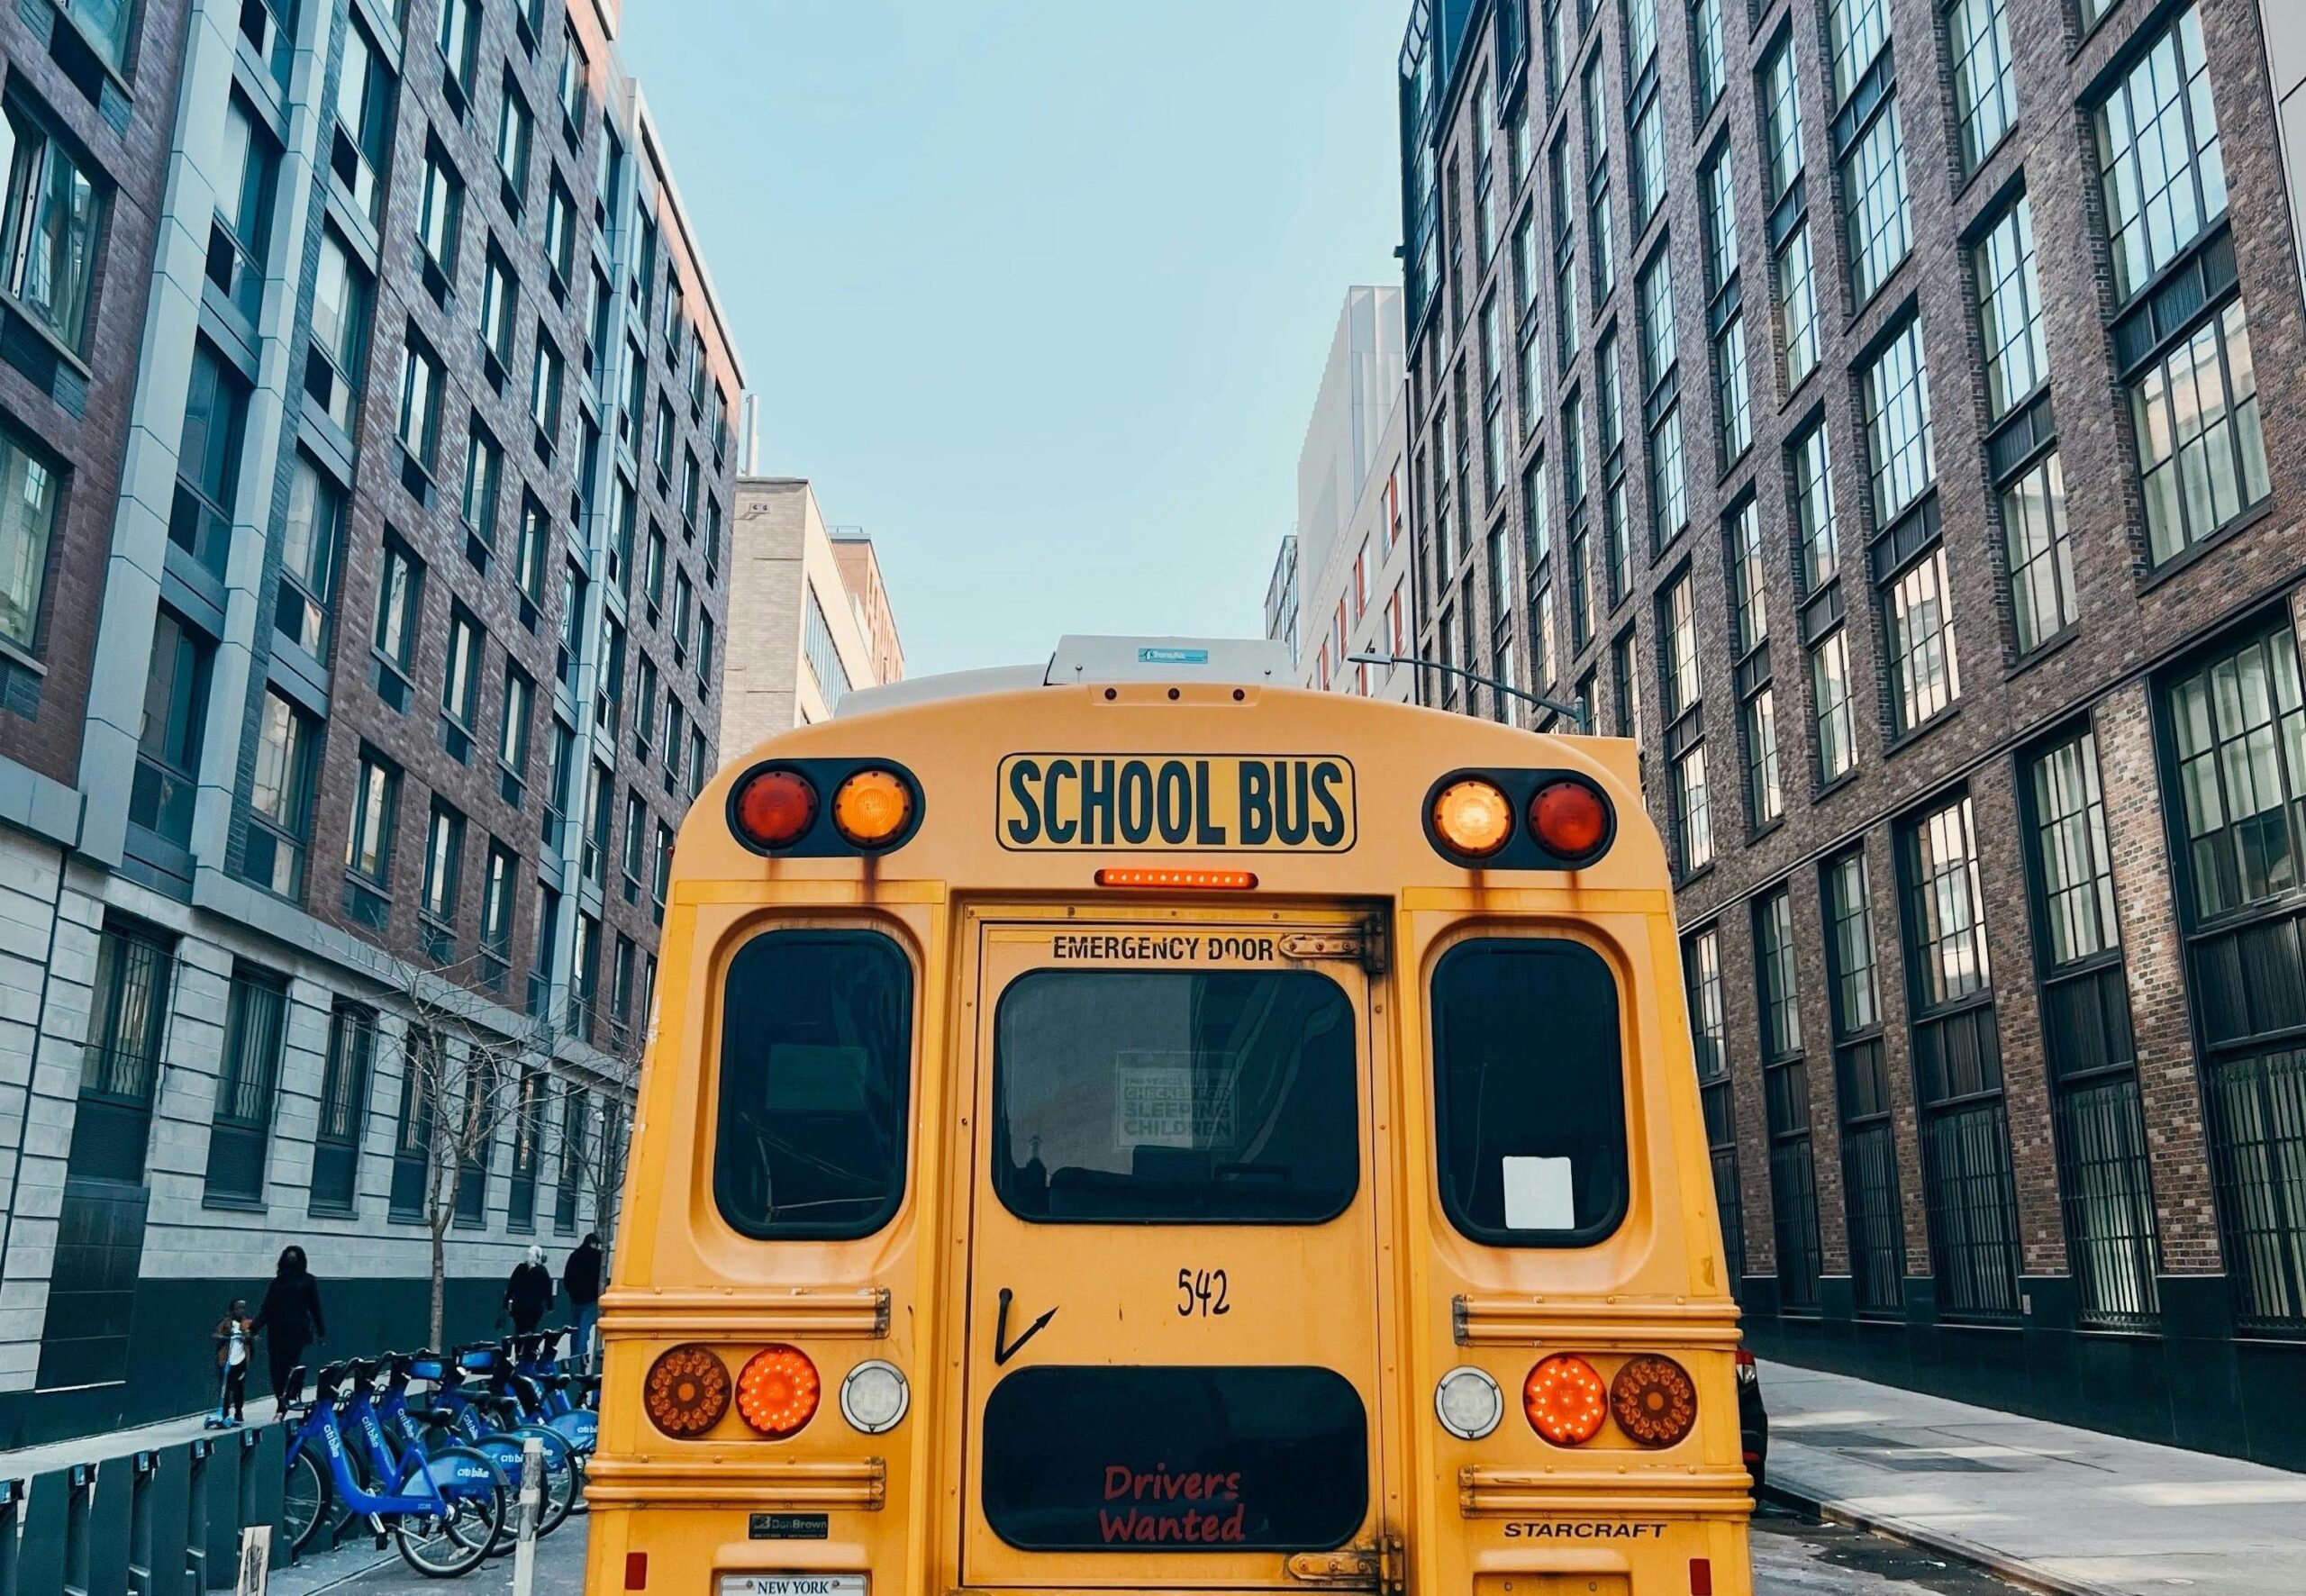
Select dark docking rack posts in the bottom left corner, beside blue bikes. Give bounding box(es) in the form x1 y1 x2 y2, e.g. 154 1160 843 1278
0 1423 286 1596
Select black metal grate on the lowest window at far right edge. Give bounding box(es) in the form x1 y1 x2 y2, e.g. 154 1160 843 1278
2209 1049 2306 1336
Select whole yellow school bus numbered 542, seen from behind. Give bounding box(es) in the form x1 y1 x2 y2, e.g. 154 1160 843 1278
588 639 1753 1596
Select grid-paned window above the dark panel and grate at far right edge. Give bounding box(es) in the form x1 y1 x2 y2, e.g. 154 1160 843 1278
2167 628 2306 920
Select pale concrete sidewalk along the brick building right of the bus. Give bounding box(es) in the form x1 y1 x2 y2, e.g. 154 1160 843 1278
1762 1363 2306 1596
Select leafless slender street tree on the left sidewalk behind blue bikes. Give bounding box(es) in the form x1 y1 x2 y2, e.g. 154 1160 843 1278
392 966 553 1347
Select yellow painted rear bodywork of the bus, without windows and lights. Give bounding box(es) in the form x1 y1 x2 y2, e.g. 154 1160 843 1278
588 685 1753 1596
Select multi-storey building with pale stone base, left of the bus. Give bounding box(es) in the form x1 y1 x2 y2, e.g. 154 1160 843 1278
0 0 742 1446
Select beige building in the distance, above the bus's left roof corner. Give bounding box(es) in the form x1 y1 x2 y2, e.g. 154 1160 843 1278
720 476 904 758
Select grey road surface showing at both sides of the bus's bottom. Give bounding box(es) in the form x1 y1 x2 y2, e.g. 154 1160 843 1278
272 1510 2015 1596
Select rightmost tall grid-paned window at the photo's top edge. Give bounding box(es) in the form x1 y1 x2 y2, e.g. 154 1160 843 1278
2096 7 2225 297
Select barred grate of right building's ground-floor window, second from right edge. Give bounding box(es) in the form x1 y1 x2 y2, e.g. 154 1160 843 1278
2052 1073 2161 1328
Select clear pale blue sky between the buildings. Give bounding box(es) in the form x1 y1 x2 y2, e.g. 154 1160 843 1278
622 0 1409 674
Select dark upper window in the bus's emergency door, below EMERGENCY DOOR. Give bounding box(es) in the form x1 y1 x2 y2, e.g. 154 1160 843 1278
994 971 1360 1225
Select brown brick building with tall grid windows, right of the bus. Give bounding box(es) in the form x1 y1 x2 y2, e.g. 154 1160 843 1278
1400 0 2306 1467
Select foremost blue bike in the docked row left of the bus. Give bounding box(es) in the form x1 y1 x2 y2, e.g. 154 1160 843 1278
281 1363 512 1578
